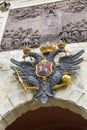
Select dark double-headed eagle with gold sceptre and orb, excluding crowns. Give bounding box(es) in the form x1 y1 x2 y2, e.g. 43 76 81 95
11 42 84 103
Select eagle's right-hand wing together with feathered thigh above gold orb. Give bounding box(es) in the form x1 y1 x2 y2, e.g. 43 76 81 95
51 50 84 87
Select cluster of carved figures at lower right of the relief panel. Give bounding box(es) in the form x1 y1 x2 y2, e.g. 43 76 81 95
59 19 87 43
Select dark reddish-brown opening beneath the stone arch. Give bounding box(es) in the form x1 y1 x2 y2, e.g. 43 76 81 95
6 107 87 130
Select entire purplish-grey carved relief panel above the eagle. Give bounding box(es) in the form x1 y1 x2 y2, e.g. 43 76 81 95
0 0 87 51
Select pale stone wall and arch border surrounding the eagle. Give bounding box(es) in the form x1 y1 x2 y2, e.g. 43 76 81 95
0 0 87 130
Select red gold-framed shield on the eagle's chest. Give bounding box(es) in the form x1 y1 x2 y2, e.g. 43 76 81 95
36 60 52 77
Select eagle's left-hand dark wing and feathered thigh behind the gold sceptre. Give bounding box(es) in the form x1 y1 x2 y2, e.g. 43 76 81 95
11 59 39 87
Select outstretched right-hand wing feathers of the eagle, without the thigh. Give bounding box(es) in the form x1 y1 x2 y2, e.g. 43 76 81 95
58 50 84 75
